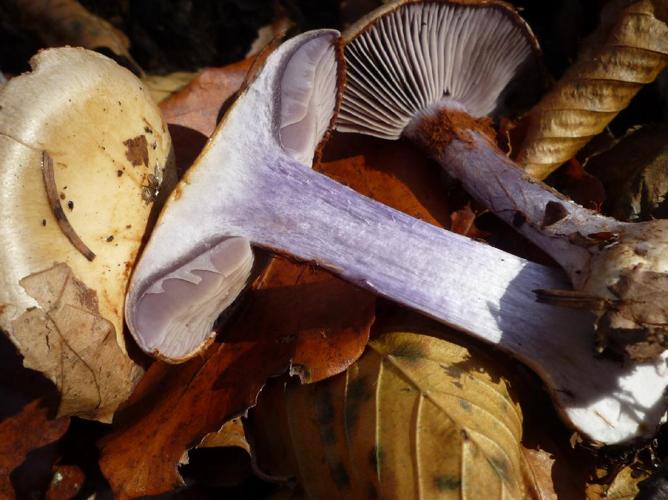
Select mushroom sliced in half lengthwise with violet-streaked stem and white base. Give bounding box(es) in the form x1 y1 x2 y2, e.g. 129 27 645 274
126 30 668 443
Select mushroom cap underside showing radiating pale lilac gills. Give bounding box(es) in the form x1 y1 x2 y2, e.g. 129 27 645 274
336 0 541 140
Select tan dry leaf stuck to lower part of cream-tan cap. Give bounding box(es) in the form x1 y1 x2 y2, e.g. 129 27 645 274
12 264 142 422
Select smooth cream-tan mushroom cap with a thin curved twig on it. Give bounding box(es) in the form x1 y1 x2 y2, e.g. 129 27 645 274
0 47 171 348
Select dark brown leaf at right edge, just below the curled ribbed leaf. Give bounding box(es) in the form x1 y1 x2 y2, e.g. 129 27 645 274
587 124 668 221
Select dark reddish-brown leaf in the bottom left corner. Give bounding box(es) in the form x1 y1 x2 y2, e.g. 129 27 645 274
0 336 70 498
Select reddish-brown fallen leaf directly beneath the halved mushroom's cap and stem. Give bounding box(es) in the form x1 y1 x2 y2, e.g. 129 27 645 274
100 258 374 496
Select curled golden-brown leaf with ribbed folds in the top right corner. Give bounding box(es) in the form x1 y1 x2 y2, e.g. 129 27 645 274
516 0 668 179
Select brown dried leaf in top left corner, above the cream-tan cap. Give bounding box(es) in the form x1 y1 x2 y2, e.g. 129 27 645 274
16 0 132 61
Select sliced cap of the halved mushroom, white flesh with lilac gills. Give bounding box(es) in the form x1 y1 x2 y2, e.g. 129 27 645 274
126 30 340 362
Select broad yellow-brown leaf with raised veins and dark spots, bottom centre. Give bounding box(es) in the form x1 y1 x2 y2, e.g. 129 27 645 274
256 333 525 498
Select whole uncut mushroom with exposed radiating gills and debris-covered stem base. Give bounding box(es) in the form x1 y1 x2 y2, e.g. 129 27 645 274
337 0 668 361
